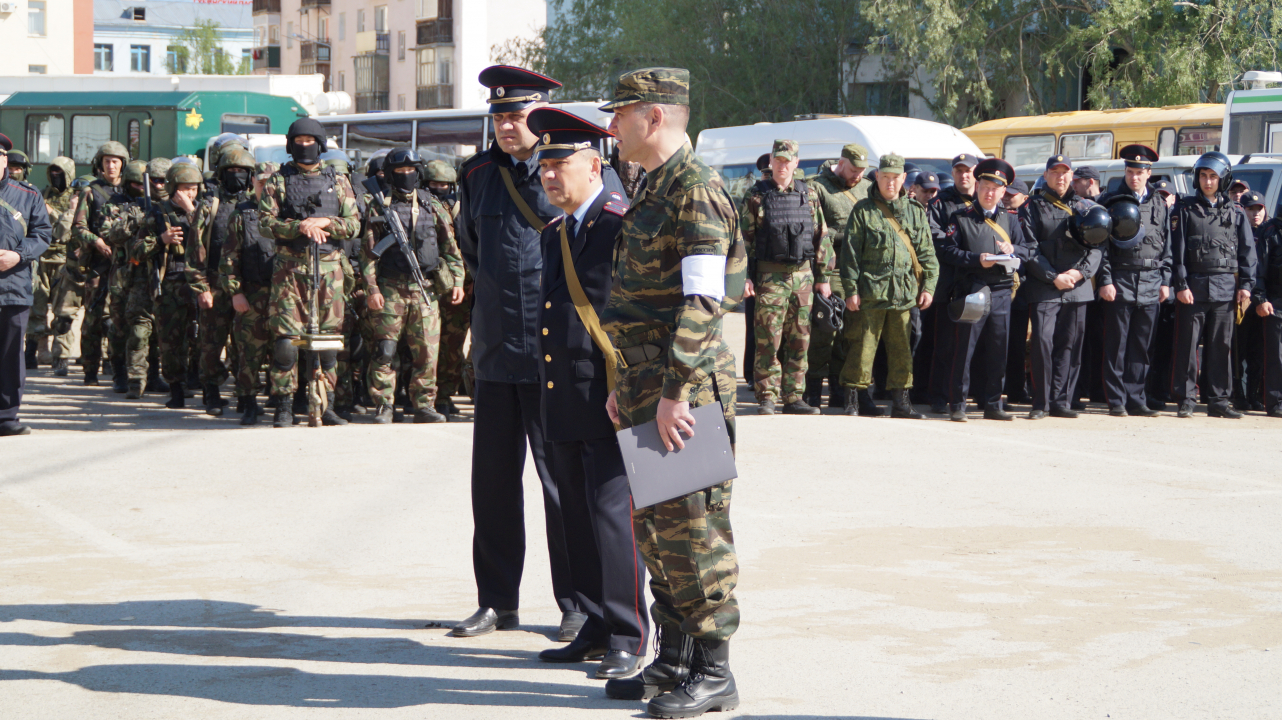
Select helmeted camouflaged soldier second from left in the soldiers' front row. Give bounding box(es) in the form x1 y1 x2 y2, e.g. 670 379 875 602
67 140 129 386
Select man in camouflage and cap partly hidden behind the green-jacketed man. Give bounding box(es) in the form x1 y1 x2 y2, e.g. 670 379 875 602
803 142 872 407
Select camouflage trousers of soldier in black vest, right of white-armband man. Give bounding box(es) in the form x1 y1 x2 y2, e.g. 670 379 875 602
753 266 814 402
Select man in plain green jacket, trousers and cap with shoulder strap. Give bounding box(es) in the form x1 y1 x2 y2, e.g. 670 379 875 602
840 154 940 420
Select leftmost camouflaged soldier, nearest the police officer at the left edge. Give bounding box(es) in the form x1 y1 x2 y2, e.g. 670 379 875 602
27 156 76 374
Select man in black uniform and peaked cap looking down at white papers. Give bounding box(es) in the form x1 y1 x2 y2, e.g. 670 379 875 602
936 158 1031 415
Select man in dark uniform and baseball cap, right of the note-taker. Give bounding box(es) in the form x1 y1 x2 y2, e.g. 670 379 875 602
1019 155 1104 420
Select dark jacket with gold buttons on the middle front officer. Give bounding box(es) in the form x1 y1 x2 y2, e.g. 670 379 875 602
538 190 628 442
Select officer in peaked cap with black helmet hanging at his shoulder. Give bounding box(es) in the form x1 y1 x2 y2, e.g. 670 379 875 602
1096 145 1170 418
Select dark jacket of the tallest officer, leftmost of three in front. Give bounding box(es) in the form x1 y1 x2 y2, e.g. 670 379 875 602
455 142 623 383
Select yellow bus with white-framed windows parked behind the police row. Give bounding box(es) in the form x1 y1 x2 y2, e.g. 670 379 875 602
962 102 1224 167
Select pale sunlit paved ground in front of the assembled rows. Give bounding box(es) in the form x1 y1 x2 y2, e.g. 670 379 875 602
0 318 1282 720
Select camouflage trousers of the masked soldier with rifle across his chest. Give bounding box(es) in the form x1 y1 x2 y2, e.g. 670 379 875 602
365 278 441 410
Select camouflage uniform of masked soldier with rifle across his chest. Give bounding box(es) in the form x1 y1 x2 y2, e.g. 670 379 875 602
360 190 463 411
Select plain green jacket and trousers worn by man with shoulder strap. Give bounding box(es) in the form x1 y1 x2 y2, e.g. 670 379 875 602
838 169 940 389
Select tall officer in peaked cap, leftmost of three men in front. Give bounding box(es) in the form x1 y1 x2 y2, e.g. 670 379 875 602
454 65 623 642
